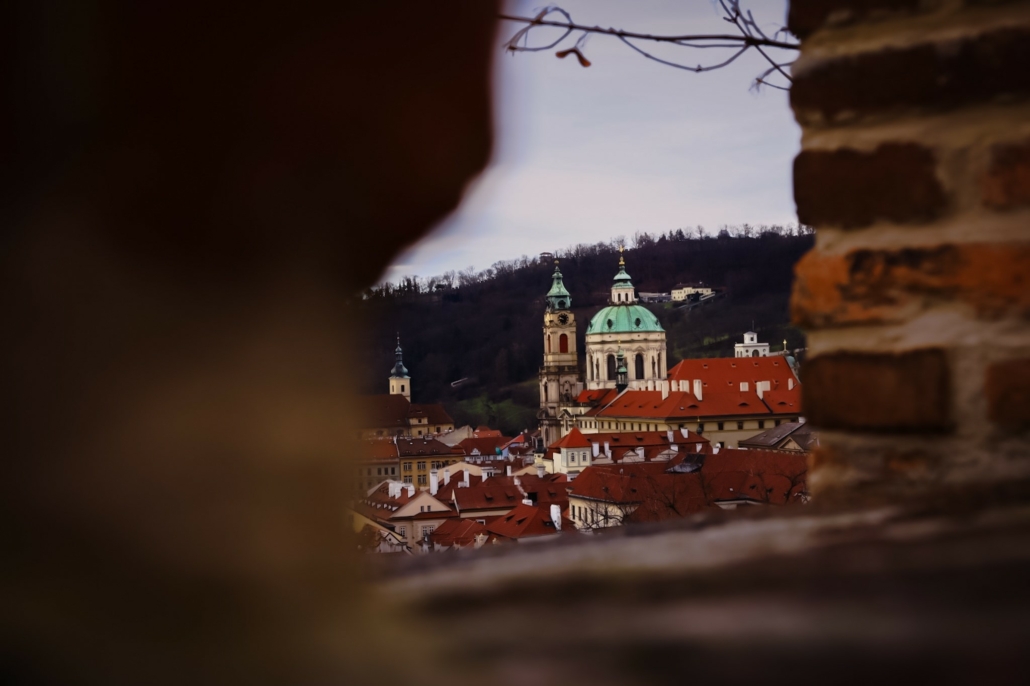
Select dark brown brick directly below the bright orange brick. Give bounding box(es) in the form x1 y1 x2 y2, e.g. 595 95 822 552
801 348 952 432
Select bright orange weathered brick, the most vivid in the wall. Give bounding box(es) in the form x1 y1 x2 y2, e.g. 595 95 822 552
791 243 1030 328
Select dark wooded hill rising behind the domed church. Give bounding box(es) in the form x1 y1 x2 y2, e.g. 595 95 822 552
353 226 814 435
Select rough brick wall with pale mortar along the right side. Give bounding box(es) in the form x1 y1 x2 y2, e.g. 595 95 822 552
788 0 1030 498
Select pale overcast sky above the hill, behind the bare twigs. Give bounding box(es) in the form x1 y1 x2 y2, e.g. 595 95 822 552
384 0 800 280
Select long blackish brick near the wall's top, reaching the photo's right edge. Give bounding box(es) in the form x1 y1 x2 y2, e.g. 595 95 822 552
790 28 1030 123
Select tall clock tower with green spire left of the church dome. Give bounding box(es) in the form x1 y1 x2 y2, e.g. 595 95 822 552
537 261 583 448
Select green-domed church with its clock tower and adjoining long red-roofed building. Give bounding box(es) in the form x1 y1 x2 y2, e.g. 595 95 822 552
538 255 801 447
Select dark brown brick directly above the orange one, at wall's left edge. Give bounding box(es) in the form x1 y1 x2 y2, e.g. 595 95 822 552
794 143 948 229
